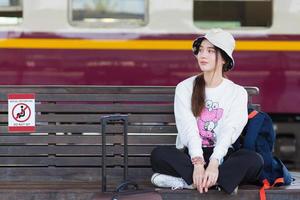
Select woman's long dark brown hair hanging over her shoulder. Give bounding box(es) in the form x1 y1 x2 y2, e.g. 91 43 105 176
191 46 231 117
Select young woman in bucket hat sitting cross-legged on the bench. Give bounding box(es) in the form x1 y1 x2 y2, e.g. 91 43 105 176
151 29 263 193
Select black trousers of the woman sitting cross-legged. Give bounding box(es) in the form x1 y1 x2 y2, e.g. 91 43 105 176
151 146 263 194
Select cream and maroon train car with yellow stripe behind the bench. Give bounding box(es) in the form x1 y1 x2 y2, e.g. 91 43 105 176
0 0 300 166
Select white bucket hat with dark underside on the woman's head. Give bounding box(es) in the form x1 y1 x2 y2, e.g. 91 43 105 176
193 28 235 71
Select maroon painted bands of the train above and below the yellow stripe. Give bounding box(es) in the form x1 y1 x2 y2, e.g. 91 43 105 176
0 32 300 115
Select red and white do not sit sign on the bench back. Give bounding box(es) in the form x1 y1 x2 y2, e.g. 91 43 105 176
8 94 35 132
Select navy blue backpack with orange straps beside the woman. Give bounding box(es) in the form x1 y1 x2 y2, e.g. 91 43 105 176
234 109 293 199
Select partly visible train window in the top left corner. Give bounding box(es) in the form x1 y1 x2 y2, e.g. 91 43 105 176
0 0 23 25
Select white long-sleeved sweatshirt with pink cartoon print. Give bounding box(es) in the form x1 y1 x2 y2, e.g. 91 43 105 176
174 76 248 163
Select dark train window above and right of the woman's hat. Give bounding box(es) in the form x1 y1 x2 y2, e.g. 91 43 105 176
194 0 273 29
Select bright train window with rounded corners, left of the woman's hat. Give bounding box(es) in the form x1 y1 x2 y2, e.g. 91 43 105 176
69 0 148 28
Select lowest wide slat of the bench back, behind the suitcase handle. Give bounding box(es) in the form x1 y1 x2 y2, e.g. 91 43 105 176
0 167 153 184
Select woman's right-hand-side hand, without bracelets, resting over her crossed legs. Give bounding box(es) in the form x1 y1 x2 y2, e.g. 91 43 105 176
202 158 219 192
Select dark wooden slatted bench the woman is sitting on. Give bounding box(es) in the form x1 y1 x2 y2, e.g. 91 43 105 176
0 86 270 198
